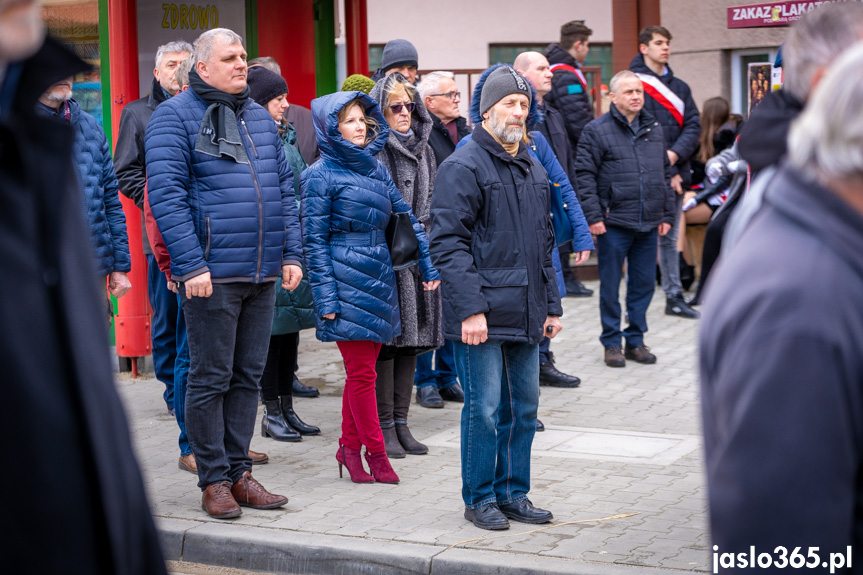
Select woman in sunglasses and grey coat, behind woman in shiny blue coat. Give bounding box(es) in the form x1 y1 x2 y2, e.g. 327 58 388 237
369 72 444 458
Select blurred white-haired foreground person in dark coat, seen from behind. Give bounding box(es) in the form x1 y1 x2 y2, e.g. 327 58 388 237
699 42 863 573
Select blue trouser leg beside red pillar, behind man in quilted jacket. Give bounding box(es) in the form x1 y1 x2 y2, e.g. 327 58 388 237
147 254 177 409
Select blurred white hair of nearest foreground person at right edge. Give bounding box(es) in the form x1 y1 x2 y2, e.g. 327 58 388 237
788 42 863 181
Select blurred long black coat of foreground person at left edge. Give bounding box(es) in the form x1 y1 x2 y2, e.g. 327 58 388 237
0 39 165 574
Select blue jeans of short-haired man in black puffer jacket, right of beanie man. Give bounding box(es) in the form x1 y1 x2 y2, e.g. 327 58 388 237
596 226 658 348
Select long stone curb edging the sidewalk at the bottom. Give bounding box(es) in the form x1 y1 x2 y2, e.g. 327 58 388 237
156 518 704 575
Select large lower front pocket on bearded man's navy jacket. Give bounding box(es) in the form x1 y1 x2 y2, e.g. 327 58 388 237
477 268 528 331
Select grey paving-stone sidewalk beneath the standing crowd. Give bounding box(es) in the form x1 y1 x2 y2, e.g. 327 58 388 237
118 282 711 573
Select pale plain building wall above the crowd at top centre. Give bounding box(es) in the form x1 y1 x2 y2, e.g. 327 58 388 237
367 0 612 70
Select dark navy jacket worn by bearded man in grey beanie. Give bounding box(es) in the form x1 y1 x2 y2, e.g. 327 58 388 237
429 127 563 344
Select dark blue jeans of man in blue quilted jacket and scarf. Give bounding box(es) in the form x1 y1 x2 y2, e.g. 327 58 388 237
180 282 276 491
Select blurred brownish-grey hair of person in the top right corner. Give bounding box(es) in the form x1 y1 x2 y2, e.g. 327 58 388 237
782 3 863 102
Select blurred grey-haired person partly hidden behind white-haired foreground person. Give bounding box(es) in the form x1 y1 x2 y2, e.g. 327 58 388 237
724 3 863 254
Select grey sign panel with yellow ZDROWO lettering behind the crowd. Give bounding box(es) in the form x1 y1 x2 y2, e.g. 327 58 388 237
137 0 246 96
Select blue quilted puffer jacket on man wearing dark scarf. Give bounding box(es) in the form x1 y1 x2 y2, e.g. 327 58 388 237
144 90 302 283
